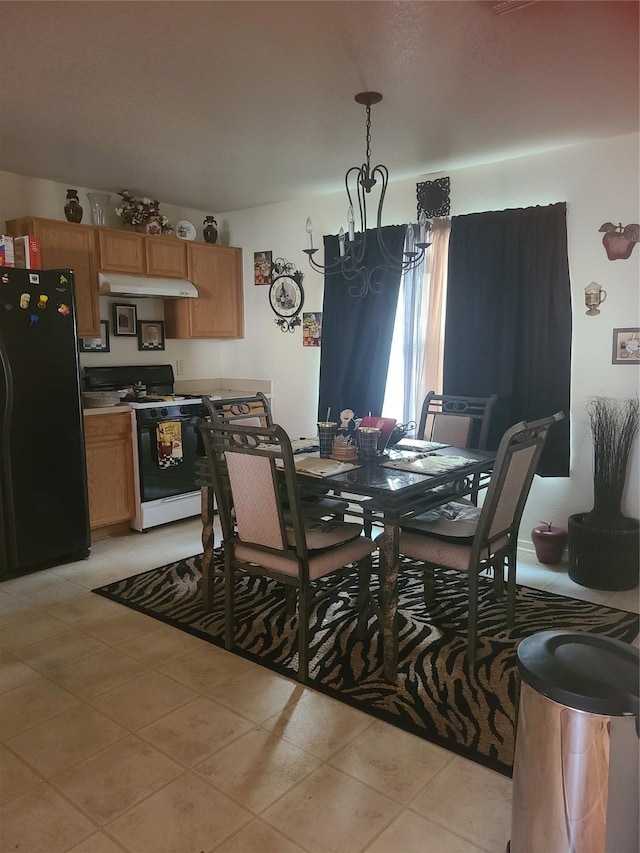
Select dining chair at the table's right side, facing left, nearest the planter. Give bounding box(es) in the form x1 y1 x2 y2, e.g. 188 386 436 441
392 412 564 663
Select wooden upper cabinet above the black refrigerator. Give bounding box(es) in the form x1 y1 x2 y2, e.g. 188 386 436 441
7 217 100 338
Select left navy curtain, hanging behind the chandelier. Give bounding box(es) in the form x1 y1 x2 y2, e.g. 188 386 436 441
318 225 406 421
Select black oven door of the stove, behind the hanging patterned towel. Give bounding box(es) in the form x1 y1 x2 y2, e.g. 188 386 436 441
137 415 199 504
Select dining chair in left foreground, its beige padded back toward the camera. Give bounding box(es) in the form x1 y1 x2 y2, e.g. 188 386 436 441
199 421 376 682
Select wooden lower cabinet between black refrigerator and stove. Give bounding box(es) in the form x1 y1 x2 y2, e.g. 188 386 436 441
84 409 135 538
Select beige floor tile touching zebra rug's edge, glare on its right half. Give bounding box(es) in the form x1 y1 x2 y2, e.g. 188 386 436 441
206 666 305 723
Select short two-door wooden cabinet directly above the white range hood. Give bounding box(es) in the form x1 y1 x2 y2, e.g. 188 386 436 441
98 228 187 278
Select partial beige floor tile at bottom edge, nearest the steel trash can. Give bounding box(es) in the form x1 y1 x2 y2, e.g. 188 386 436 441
365 812 482 853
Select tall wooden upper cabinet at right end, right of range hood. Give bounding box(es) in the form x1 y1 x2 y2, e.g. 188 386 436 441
164 243 244 338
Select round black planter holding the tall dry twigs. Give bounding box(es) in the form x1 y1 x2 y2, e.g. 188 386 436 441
568 512 640 590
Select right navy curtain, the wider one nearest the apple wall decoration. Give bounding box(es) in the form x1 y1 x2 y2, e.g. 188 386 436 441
444 202 571 477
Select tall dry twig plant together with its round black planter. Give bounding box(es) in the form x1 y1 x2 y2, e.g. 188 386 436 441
568 397 640 590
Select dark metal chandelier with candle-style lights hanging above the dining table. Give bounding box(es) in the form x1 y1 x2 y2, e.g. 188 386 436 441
303 92 431 296
